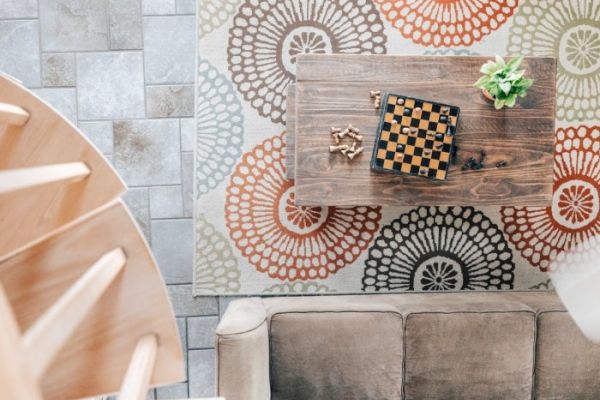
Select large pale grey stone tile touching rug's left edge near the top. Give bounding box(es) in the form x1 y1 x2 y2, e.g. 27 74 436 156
144 15 196 84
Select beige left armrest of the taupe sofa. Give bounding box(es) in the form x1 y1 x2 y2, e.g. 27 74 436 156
216 298 271 400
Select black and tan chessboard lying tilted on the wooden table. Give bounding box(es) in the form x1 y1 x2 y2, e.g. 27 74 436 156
371 93 460 180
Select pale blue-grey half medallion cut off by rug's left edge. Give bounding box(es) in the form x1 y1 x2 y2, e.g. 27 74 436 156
195 59 244 197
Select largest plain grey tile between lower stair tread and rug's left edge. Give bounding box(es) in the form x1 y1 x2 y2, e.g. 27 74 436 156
151 219 194 284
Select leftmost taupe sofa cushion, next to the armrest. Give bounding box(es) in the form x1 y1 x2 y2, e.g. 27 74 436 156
270 310 403 400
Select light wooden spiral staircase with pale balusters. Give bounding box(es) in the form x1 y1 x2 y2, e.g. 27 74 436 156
0 75 185 400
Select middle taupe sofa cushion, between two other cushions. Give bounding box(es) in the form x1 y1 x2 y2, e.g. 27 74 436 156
404 311 535 400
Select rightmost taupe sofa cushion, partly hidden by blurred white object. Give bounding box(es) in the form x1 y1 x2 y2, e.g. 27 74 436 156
535 312 600 400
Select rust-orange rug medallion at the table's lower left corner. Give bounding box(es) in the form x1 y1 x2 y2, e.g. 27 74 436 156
225 134 381 281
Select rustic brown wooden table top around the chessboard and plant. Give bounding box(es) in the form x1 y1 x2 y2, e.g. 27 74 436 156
286 54 556 206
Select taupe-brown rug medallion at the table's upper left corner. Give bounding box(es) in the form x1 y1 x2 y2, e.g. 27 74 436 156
227 0 386 123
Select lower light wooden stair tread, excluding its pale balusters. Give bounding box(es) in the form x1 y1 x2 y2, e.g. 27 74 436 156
0 200 185 400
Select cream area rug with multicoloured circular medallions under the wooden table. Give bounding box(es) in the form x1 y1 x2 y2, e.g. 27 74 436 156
195 0 600 295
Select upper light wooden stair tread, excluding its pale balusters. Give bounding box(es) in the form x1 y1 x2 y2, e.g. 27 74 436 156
0 74 125 260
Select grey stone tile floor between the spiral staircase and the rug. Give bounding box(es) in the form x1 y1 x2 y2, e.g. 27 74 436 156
0 0 225 399
